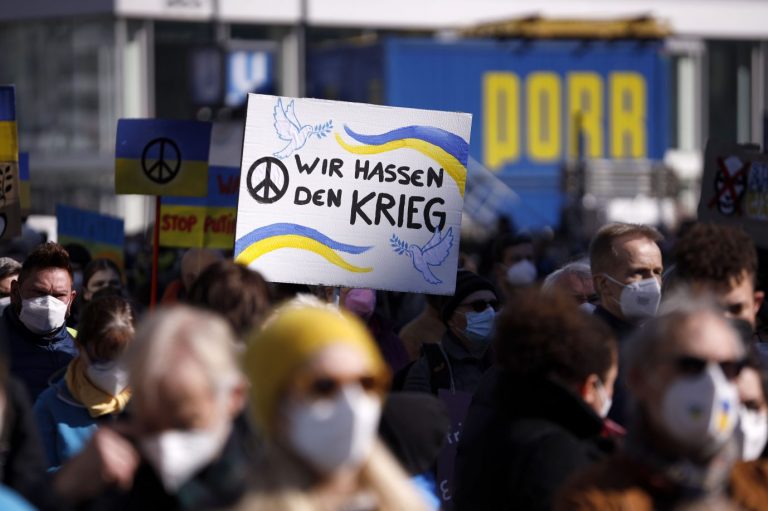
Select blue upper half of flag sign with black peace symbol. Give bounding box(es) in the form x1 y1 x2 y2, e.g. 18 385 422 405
115 119 211 162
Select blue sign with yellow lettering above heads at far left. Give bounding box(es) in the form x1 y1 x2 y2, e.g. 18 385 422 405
56 204 125 268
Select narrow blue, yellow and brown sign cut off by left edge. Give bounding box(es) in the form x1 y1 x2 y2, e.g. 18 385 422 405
0 85 21 240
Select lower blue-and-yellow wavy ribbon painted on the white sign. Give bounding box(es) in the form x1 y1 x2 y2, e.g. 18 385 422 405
235 223 373 273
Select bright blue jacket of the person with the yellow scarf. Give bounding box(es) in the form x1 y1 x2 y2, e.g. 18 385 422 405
33 378 110 471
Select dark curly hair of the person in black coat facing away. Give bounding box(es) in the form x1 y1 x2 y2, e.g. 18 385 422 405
494 290 618 384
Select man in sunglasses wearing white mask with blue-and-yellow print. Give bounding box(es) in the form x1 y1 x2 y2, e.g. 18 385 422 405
555 299 768 511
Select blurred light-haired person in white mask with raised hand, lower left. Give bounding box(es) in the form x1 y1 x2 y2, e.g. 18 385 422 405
57 306 253 511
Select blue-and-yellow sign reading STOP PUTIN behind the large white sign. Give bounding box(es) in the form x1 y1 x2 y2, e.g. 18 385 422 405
160 166 240 250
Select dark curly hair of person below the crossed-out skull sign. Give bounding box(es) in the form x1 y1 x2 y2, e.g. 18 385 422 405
675 223 757 285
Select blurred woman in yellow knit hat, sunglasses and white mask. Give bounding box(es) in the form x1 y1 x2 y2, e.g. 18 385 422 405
241 306 426 511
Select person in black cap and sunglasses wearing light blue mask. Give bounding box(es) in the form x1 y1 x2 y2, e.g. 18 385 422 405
403 270 499 394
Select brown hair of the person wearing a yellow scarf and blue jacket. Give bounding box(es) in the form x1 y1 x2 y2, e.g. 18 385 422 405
76 295 135 361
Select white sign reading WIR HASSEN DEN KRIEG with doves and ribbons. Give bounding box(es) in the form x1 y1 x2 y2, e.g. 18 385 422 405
235 94 472 294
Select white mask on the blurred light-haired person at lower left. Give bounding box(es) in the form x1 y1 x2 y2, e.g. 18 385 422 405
140 419 231 494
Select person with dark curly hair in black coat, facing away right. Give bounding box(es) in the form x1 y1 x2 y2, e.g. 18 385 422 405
454 290 618 511
